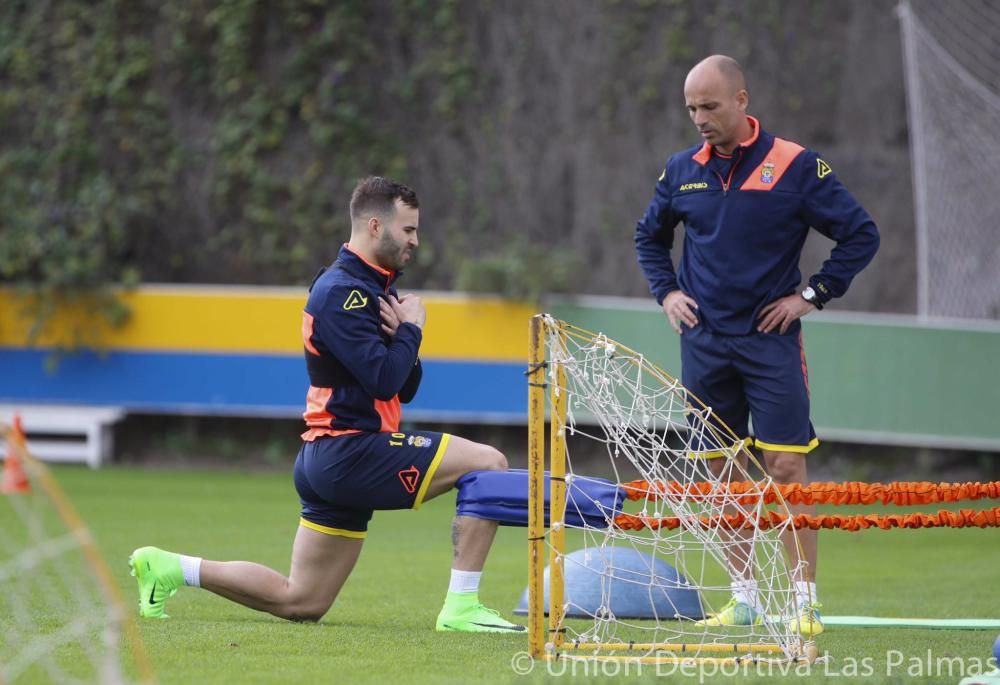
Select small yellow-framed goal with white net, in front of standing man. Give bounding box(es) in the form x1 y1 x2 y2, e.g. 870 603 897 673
527 314 816 663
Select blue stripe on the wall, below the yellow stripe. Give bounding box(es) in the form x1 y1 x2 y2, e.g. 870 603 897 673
0 349 527 422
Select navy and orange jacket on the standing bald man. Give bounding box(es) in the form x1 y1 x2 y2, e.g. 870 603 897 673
635 117 879 335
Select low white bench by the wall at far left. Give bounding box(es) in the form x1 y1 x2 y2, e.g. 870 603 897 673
0 404 125 469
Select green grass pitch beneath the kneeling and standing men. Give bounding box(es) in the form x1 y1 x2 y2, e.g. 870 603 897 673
7 467 1000 685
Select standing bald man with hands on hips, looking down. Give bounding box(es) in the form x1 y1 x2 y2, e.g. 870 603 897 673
635 55 879 637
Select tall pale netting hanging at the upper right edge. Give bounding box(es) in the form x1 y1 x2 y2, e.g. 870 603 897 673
899 0 1000 319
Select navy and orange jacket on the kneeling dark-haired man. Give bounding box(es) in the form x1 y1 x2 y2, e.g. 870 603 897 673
302 245 422 441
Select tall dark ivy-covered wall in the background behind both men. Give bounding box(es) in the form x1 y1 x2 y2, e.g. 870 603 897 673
0 0 913 318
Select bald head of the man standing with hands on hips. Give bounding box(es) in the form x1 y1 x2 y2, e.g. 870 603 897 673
684 55 753 154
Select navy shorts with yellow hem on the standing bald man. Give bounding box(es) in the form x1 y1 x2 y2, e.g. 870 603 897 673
681 326 819 457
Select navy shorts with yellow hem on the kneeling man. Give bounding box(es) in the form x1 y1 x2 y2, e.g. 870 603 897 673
293 431 451 538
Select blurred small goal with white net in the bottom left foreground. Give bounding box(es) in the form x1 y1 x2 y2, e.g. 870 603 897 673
0 424 152 685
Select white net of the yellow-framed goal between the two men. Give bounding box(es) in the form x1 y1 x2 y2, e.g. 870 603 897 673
545 319 803 658
